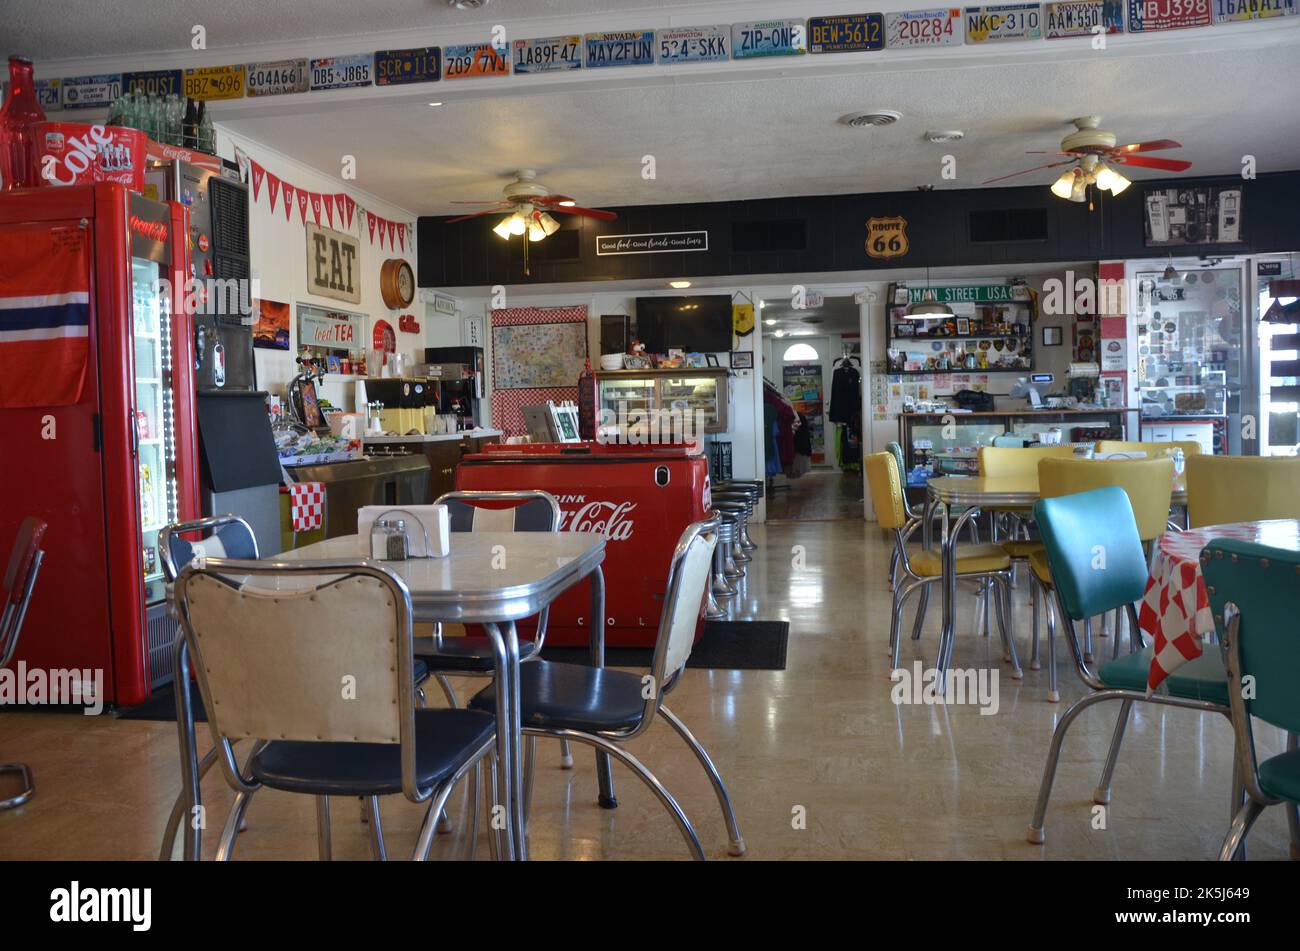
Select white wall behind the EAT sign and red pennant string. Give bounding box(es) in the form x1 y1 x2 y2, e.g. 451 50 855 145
217 126 421 411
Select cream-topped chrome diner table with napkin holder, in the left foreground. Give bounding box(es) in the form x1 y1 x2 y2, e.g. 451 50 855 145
163 531 614 860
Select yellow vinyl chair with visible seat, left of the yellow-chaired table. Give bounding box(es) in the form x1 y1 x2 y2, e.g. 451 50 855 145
863 452 1023 679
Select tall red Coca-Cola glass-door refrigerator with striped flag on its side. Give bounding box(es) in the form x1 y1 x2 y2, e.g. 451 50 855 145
0 183 198 705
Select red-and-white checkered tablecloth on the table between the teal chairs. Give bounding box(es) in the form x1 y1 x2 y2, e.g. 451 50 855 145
1138 518 1300 692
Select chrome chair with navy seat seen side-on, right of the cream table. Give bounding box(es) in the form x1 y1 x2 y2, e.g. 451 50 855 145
469 520 745 860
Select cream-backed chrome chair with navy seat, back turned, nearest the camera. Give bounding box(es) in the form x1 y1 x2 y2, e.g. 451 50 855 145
176 559 497 861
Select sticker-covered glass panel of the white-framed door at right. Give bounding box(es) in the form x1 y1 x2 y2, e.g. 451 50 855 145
1134 266 1244 420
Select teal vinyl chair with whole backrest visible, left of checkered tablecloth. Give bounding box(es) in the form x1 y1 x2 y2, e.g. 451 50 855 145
1028 486 1242 844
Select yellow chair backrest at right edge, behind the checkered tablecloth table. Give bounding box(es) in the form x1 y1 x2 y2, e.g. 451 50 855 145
1187 456 1300 529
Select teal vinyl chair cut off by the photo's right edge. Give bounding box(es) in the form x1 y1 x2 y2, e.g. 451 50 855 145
1201 539 1300 861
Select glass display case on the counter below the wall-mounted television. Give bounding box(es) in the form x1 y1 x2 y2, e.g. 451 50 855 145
595 368 728 434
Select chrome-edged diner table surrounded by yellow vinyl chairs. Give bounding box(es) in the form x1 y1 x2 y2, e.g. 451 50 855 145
920 472 1187 682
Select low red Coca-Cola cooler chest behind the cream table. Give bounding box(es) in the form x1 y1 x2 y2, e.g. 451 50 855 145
456 443 712 647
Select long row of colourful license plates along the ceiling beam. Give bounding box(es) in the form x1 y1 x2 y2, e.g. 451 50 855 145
27 0 1300 109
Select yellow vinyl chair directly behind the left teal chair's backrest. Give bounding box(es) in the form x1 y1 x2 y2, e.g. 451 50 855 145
1030 457 1174 703
